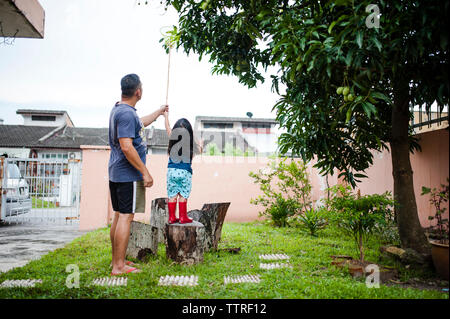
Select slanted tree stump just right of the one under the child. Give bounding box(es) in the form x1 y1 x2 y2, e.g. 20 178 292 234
188 203 230 251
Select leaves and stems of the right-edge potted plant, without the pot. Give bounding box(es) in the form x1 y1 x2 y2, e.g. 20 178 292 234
422 178 449 244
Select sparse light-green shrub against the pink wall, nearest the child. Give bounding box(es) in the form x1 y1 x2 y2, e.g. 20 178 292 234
249 158 311 227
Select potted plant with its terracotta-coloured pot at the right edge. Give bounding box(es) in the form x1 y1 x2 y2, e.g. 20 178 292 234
422 178 449 280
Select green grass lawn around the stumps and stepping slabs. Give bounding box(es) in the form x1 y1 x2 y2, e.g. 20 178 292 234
0 223 449 299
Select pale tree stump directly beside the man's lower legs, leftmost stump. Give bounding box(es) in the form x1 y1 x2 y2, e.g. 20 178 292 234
126 221 158 260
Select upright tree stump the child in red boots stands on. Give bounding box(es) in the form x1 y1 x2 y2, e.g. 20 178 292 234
165 221 205 264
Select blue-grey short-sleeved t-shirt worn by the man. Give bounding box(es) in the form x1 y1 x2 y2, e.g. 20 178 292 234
108 103 147 183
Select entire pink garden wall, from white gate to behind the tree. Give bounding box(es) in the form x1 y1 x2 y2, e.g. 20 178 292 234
80 130 449 230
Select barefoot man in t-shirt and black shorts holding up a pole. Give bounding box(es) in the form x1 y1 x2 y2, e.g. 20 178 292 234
108 74 168 275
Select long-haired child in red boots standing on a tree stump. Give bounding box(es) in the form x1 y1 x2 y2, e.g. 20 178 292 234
164 112 202 224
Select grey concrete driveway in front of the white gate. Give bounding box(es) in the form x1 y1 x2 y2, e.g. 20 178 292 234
0 223 86 272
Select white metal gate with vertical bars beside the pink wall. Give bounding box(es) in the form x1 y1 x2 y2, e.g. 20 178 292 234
0 158 81 224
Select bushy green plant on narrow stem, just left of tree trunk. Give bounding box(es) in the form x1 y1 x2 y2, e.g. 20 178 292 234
329 185 394 262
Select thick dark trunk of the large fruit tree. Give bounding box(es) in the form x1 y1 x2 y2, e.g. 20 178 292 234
390 80 431 255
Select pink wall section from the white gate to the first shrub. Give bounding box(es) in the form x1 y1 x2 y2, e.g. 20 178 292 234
80 146 282 230
